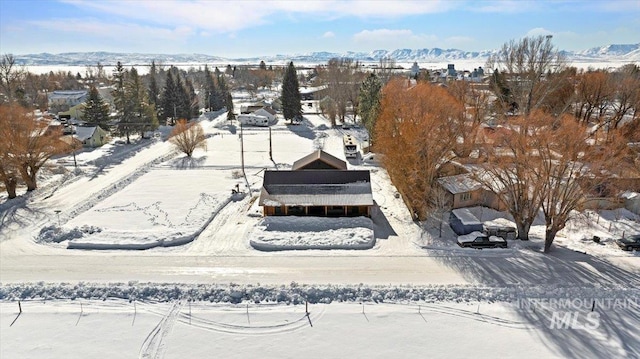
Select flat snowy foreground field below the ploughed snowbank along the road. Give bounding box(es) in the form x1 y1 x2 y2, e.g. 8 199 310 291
0 300 640 359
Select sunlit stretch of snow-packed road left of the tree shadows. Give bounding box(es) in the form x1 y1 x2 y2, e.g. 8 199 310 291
0 253 467 284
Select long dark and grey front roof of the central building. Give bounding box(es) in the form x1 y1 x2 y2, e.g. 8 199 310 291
258 170 373 206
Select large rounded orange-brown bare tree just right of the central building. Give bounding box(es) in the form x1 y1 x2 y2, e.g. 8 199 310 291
374 79 462 220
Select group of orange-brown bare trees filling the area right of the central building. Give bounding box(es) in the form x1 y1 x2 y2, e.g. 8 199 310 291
372 37 640 252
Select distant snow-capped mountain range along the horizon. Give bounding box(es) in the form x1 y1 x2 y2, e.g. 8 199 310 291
14 43 640 66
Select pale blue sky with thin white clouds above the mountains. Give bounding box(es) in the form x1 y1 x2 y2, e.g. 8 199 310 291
0 0 640 58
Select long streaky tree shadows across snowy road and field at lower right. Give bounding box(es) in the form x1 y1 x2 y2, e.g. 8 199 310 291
434 246 640 358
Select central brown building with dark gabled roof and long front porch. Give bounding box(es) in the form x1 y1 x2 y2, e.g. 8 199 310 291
258 151 374 217
